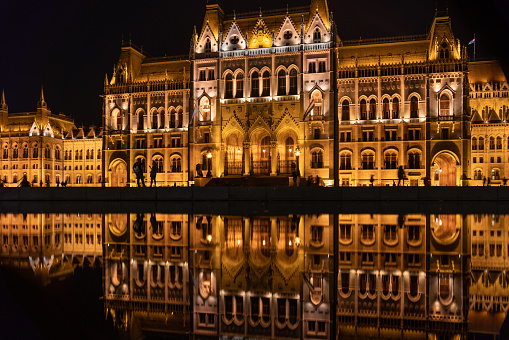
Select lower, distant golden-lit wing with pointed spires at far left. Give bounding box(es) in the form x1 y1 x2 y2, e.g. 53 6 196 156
0 90 103 186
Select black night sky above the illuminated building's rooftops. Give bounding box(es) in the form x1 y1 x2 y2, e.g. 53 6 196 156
0 0 509 125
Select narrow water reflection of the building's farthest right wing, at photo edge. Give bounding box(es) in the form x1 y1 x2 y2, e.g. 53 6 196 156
467 215 509 334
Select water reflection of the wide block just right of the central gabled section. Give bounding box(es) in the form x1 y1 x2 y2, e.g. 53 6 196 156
338 215 466 339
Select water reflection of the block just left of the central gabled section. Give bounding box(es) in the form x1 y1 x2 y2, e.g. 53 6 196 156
104 214 189 336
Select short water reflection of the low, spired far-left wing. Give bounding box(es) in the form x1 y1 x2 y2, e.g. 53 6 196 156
0 214 102 284
